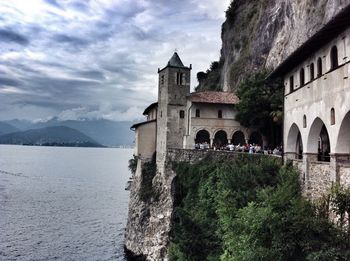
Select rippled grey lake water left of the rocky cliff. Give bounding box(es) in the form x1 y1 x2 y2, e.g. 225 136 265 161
0 145 132 260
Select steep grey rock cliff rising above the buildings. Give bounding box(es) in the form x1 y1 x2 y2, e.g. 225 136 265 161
202 0 350 91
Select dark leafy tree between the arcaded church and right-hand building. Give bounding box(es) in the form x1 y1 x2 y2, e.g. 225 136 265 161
237 71 283 146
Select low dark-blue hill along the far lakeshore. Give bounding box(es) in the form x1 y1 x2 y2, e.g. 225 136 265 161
0 126 101 147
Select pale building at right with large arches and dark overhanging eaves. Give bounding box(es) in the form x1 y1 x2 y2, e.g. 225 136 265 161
270 5 350 198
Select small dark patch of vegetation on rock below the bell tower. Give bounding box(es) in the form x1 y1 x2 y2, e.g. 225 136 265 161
139 153 158 202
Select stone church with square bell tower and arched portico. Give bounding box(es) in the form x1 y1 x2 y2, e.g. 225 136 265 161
132 52 266 171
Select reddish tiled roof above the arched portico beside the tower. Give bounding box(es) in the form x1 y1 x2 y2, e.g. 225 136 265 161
190 91 239 104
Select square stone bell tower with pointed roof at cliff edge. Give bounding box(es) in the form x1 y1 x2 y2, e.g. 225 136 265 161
157 52 192 168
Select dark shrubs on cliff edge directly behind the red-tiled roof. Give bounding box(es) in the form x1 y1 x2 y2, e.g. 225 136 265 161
196 62 221 91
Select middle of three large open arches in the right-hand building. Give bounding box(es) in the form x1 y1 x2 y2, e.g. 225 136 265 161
307 118 331 161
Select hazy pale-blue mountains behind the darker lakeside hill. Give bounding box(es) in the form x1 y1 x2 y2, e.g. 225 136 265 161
1 118 134 146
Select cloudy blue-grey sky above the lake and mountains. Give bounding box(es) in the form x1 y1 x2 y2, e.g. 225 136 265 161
0 0 230 121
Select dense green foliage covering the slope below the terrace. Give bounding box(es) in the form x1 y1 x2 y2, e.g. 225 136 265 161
169 155 350 260
